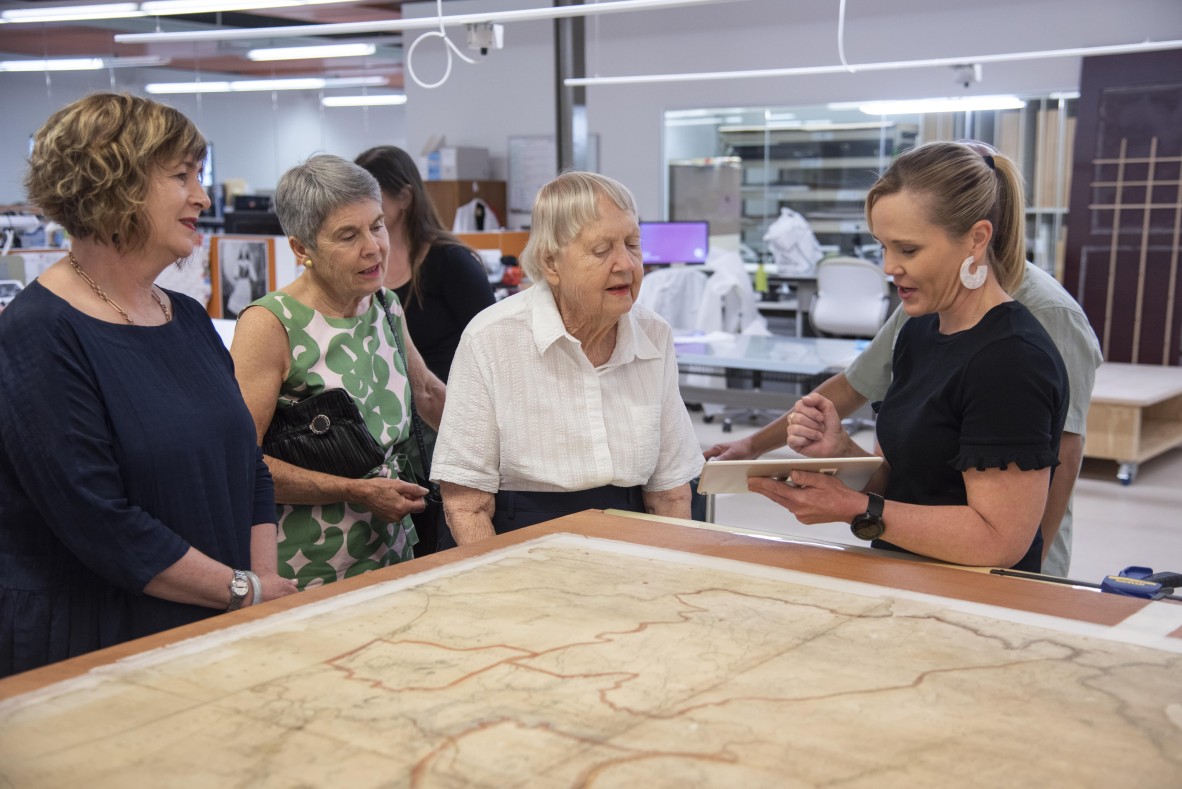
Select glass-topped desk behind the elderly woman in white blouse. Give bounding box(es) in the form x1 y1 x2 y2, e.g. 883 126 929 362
676 334 869 410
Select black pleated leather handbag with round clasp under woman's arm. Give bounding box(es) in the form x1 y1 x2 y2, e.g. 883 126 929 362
262 389 385 480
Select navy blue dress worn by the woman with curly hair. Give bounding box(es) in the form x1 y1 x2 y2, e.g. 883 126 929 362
0 282 275 677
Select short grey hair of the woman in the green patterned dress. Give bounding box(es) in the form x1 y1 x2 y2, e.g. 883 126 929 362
275 154 382 249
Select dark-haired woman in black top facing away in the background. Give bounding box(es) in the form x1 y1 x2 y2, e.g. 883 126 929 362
356 145 496 383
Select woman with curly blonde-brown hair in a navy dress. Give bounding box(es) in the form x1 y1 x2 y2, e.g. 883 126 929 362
0 93 294 676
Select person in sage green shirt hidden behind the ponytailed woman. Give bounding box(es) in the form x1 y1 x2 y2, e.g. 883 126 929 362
704 262 1103 575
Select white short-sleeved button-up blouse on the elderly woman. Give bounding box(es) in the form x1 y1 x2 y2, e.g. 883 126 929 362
431 283 702 493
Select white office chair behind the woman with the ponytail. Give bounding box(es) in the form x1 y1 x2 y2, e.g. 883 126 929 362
808 257 890 435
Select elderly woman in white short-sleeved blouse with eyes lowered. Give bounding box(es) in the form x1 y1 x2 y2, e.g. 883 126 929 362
431 172 702 545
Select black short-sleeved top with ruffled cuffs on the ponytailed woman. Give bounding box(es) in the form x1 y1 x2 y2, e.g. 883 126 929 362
877 301 1069 570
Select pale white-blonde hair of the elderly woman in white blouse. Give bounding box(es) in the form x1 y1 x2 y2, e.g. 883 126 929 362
521 170 637 282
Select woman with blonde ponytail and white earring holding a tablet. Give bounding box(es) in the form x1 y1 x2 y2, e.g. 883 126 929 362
751 143 1069 570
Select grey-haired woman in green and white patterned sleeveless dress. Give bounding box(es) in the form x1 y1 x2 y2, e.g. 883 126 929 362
230 155 444 589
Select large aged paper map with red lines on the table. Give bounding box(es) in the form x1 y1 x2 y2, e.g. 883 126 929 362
0 535 1182 789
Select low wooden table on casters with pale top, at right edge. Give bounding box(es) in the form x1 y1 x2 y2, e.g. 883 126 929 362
1084 361 1182 484
